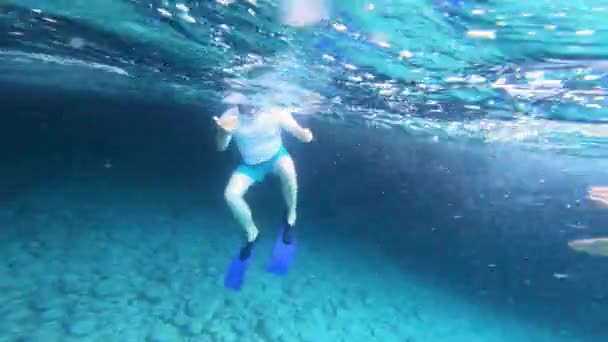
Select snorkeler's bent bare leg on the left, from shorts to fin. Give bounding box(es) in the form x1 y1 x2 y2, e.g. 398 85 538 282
224 172 258 242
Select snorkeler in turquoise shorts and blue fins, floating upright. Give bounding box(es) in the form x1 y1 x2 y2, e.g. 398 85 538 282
214 93 313 290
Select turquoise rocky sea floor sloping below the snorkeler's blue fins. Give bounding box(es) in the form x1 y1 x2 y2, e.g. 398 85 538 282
0 185 587 342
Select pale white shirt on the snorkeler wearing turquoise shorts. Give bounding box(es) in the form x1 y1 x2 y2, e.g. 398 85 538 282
224 110 291 165
